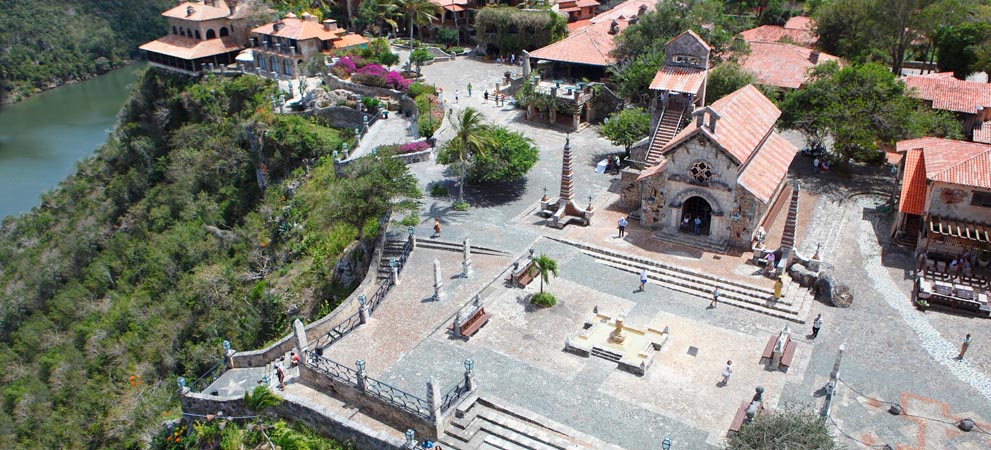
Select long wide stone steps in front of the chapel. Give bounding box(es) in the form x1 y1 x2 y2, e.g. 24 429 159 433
554 239 813 324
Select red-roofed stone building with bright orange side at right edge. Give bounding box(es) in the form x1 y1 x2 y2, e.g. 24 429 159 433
892 137 991 259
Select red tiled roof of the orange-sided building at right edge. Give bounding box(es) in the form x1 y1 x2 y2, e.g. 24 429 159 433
897 137 991 189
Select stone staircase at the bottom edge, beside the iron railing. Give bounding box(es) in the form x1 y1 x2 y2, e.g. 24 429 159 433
439 394 622 450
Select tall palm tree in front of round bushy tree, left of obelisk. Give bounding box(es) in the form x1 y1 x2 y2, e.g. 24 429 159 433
437 107 495 203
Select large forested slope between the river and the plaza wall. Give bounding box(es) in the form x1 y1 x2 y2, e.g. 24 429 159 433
0 71 404 448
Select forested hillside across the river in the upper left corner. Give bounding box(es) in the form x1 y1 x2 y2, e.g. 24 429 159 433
0 0 175 102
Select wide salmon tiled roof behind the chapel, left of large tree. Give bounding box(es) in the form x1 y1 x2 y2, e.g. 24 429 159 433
739 42 839 89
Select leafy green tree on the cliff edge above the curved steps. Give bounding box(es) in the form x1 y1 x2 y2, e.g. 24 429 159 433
320 153 421 240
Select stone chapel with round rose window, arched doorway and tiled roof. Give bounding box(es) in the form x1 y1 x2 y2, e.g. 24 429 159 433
630 85 797 249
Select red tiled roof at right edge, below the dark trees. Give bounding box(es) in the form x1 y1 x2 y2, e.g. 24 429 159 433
904 73 991 114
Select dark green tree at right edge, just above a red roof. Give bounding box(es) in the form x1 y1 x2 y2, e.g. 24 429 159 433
936 22 991 80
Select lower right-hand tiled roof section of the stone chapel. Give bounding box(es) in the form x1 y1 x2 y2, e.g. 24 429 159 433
736 132 798 203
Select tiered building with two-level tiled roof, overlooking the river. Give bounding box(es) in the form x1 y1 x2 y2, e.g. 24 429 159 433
139 0 254 74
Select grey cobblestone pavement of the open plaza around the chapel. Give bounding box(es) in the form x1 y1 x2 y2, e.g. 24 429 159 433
312 59 991 450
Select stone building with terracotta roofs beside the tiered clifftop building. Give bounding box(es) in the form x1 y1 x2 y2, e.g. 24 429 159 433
251 13 368 78
